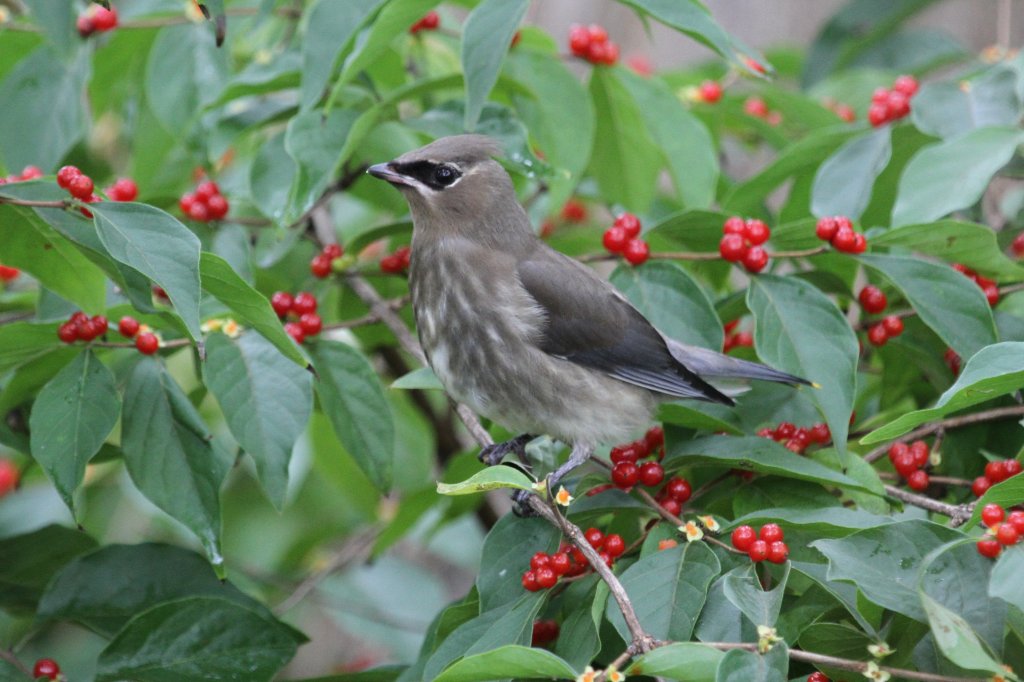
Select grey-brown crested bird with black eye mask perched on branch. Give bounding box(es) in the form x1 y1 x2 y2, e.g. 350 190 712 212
368 135 808 489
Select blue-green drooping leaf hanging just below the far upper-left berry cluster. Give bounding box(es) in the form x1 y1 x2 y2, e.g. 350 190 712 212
90 202 201 340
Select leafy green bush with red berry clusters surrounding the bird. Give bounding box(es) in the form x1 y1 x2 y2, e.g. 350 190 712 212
0 0 1024 682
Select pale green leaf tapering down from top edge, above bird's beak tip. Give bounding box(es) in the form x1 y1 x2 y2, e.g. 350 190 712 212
299 0 385 111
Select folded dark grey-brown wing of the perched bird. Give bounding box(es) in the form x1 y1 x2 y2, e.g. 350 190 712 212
517 251 733 404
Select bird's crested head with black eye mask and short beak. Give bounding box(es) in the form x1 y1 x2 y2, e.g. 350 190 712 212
367 135 528 237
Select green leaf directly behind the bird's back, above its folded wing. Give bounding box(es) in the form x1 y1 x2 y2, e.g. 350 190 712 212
610 260 723 349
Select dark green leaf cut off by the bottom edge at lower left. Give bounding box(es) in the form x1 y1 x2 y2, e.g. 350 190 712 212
96 596 301 682
